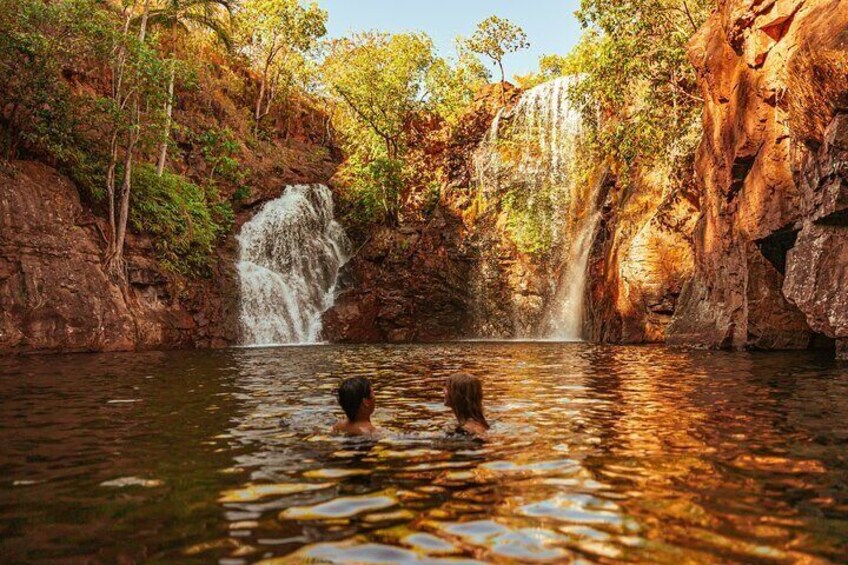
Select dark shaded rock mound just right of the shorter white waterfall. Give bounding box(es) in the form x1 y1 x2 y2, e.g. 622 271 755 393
323 209 473 342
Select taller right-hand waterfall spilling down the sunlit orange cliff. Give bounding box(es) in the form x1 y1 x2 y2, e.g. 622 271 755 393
475 77 601 341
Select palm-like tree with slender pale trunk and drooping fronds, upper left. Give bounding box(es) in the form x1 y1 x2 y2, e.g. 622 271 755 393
148 0 232 176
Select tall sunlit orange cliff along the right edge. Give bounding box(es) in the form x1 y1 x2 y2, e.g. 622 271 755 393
668 0 848 356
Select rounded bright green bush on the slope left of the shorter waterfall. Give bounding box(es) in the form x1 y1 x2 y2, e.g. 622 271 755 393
130 164 233 276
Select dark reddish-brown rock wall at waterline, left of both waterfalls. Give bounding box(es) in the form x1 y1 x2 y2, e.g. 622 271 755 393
0 161 237 352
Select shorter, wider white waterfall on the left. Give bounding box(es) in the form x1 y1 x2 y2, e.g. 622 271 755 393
238 185 350 345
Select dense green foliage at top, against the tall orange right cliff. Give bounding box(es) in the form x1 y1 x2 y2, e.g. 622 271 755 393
568 0 713 180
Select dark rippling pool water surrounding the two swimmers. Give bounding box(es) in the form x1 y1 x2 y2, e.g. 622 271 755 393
0 343 848 564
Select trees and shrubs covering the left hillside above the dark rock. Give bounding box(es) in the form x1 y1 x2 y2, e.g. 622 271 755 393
0 0 326 280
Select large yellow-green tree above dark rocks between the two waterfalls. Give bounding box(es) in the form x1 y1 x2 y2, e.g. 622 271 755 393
321 32 449 223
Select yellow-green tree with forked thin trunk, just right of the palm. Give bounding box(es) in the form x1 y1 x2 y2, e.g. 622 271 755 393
236 0 327 131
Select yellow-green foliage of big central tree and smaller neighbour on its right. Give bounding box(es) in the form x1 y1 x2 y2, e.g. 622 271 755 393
322 33 488 223
